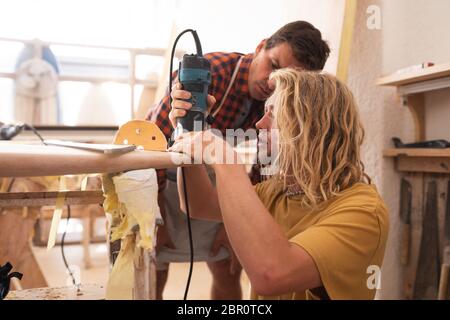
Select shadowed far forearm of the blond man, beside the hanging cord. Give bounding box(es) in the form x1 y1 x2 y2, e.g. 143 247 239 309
177 165 222 221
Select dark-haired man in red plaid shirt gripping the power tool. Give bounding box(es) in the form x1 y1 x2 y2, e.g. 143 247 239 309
146 21 330 299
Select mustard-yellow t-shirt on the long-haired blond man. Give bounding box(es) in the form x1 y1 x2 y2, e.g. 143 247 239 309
251 181 389 300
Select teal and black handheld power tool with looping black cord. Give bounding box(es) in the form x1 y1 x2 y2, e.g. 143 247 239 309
169 29 211 137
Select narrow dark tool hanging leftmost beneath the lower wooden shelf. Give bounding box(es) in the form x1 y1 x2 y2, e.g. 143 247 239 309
400 178 412 266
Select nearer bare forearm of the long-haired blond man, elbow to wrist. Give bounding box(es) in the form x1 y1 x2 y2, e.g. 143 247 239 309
215 165 322 295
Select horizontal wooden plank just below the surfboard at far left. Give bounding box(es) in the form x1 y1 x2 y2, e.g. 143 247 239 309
0 190 104 208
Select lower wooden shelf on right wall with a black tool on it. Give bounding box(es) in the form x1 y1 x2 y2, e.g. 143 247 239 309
383 148 450 173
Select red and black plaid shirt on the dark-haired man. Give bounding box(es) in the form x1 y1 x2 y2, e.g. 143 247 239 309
146 52 264 191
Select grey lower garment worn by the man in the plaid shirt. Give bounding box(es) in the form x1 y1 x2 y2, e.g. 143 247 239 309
156 179 229 270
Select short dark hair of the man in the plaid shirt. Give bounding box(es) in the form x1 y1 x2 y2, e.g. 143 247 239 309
265 21 330 71
